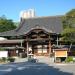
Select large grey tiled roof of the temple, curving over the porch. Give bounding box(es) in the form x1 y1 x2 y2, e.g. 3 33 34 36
0 16 63 36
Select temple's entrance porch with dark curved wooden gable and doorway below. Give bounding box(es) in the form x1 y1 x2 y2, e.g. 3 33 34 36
25 29 51 56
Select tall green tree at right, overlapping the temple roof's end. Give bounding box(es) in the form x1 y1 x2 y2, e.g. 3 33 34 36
62 9 75 48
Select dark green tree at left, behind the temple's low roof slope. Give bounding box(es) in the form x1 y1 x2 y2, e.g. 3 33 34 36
0 16 16 32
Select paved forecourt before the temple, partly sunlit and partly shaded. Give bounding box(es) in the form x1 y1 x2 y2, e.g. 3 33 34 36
0 57 75 75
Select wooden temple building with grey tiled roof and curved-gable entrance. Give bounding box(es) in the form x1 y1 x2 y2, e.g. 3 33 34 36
0 16 63 56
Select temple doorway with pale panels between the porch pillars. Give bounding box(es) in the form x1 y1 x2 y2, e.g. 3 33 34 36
28 41 49 56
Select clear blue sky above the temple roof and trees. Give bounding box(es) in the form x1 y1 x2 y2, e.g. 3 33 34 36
0 0 75 21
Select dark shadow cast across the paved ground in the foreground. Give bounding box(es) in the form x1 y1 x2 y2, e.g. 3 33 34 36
1 62 73 75
